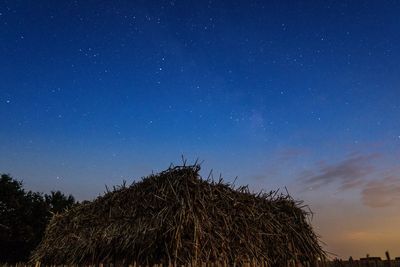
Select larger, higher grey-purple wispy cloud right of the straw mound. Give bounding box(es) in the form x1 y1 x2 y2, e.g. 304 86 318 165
301 154 377 190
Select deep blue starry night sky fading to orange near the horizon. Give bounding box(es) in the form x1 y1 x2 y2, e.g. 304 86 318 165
0 0 400 258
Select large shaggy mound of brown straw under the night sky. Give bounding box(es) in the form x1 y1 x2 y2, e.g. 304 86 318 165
32 165 325 266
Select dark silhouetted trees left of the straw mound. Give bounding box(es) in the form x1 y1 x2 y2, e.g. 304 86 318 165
0 174 78 263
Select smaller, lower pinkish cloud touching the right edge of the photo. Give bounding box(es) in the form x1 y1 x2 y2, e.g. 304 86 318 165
361 176 400 208
